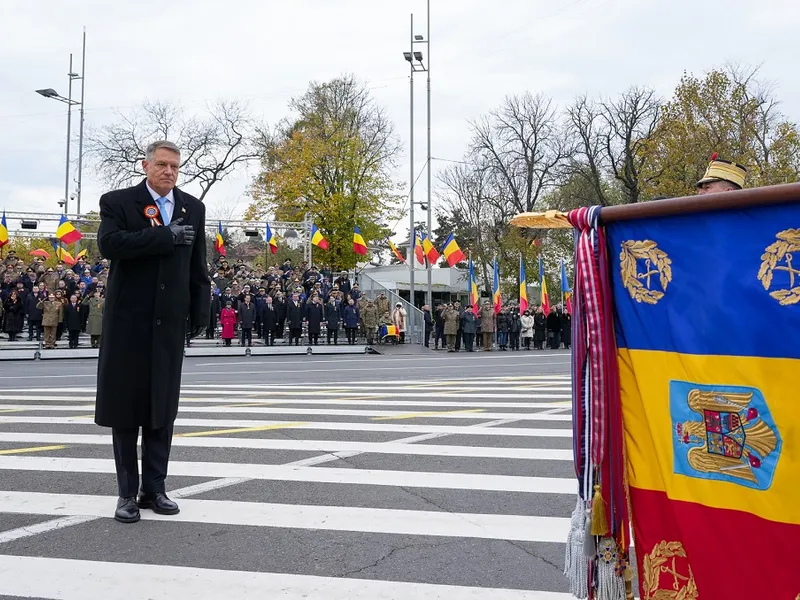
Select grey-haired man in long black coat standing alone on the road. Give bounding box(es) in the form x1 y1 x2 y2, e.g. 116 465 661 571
95 141 210 523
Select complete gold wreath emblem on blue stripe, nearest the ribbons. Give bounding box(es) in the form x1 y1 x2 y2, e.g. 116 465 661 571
619 240 672 304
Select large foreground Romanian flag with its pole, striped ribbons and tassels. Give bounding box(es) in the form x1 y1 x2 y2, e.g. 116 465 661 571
513 182 800 600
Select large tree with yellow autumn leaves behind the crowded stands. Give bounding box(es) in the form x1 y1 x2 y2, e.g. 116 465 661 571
245 76 399 269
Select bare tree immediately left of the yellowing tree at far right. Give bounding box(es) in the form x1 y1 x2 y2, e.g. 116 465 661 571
567 87 661 205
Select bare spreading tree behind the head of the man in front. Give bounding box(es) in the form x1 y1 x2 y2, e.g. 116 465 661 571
86 101 263 200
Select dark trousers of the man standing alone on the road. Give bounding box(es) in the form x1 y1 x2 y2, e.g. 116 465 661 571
111 424 172 498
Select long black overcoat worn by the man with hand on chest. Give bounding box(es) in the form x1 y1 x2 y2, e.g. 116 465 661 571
95 181 211 429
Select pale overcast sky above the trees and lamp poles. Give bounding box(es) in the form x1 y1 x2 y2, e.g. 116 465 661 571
0 0 800 232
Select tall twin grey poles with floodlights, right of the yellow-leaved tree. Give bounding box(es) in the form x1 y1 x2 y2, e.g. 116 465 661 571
403 0 433 325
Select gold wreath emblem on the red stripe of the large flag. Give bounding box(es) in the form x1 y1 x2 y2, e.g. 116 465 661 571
642 541 699 600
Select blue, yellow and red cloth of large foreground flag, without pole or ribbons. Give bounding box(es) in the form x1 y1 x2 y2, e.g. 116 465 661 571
606 203 800 600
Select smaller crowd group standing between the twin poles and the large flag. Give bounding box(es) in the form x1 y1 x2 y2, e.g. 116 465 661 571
434 300 572 352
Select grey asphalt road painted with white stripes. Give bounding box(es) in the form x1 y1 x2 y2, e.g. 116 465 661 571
0 351 574 600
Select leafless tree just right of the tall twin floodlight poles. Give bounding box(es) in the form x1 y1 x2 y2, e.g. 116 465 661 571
470 93 573 217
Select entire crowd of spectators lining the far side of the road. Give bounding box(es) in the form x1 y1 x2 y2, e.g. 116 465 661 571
0 251 571 352
